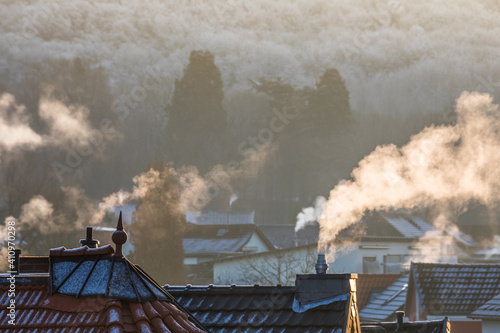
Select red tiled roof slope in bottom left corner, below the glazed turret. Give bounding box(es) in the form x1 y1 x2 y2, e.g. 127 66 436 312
0 279 203 333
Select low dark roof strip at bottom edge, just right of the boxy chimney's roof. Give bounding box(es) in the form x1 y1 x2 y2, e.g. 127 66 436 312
361 317 451 333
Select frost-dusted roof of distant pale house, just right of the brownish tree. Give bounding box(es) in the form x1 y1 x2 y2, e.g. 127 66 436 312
182 224 273 255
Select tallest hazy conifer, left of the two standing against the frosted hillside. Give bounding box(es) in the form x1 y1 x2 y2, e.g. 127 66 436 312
167 51 228 173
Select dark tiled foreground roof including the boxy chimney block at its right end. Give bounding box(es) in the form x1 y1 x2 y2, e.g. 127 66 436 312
165 264 361 333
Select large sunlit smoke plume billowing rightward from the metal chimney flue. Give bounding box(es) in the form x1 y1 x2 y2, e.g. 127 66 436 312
319 92 500 250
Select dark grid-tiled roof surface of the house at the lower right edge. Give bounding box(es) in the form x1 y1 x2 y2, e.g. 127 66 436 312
407 263 500 316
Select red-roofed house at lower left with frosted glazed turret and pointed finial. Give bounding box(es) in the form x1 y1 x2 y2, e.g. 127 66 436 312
0 214 207 333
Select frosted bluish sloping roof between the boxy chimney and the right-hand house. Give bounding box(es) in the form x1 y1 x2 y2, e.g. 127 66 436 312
359 275 409 321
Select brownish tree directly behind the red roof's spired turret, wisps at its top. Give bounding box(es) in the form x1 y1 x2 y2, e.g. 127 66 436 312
130 167 186 284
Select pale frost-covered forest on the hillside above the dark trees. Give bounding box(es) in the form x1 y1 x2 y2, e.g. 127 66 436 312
0 0 500 114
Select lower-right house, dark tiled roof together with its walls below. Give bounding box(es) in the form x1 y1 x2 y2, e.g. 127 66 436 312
405 263 500 333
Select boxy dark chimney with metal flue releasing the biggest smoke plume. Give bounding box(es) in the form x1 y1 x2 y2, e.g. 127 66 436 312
293 254 358 313
